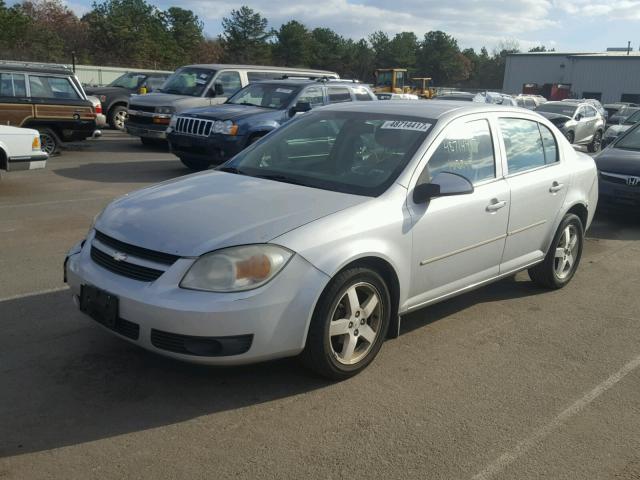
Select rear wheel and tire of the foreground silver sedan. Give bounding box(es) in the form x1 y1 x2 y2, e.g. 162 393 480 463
529 213 584 289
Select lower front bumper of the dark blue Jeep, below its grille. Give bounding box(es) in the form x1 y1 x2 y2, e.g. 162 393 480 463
167 131 248 163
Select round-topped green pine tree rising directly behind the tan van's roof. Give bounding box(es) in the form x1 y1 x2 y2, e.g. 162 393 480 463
220 5 274 64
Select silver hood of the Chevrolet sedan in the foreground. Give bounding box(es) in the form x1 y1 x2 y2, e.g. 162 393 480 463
95 171 369 257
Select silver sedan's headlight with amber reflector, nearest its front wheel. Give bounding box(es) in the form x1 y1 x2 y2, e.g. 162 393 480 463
180 244 293 292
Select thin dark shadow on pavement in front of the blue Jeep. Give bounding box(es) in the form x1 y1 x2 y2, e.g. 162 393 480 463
52 158 193 184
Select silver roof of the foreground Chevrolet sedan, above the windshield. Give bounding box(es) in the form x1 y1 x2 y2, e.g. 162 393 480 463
312 100 528 119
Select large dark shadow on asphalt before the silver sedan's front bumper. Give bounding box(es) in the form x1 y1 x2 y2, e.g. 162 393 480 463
0 291 330 458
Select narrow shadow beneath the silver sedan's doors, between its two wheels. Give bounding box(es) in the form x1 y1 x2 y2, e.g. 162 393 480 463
400 272 549 335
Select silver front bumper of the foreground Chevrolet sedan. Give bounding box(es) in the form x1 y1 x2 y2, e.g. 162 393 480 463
65 233 329 365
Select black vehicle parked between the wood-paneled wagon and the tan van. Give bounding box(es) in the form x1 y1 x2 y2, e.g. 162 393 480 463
85 72 171 130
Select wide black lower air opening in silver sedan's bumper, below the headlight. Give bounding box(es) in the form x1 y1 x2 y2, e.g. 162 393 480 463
151 329 253 357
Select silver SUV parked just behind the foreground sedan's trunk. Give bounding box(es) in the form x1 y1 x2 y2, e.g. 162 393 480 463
536 102 605 153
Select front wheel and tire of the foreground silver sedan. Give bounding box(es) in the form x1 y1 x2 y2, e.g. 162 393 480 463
302 267 391 380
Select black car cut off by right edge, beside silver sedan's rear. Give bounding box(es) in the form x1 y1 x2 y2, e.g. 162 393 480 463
595 124 640 212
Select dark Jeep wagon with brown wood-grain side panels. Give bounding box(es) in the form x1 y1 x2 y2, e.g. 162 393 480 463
0 62 96 155
